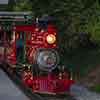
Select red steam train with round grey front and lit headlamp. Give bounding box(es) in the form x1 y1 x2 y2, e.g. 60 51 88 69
0 12 74 94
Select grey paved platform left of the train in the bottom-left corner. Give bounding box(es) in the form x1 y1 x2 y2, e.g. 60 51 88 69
0 69 29 100
